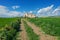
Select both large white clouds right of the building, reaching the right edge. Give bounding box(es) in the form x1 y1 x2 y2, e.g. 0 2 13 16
37 5 60 17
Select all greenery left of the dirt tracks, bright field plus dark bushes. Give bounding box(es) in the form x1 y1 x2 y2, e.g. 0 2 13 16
0 18 21 40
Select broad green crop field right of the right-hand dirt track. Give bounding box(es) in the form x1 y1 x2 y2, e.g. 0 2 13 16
28 17 60 36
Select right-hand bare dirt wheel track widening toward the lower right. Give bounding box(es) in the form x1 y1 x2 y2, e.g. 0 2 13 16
25 20 57 40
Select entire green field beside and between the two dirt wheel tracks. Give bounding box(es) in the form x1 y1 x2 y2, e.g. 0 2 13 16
0 17 60 40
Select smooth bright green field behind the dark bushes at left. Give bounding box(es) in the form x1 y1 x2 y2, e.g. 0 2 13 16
0 18 17 27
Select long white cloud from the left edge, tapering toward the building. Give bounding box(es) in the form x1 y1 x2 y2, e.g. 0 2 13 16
0 5 22 17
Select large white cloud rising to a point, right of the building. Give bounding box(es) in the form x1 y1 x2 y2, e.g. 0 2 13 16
37 5 54 16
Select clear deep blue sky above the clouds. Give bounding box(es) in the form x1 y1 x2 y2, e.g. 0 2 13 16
0 0 60 11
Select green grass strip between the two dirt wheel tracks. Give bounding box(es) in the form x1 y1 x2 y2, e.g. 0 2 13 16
24 21 39 40
